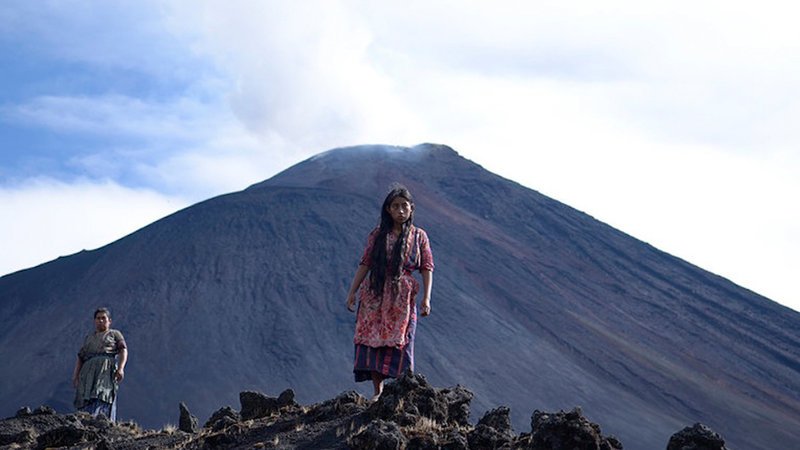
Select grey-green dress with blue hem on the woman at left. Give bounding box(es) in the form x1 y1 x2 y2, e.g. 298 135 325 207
75 329 127 421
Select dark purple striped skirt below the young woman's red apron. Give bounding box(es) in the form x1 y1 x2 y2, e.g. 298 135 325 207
353 305 417 382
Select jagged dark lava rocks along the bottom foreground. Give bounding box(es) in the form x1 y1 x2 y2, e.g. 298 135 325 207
0 374 725 450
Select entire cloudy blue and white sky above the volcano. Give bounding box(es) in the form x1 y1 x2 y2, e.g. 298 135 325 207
0 0 800 309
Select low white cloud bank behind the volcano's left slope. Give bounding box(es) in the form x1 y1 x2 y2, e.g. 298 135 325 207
0 178 188 274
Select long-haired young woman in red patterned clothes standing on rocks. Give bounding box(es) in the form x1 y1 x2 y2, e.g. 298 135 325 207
347 186 434 400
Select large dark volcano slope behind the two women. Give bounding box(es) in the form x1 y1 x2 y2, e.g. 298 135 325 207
0 145 800 450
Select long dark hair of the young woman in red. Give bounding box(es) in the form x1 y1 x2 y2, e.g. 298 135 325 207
369 184 414 296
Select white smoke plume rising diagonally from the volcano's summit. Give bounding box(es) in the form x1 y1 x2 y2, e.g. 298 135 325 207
163 2 418 151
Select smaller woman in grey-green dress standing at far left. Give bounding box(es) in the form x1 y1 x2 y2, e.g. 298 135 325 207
72 308 128 422
